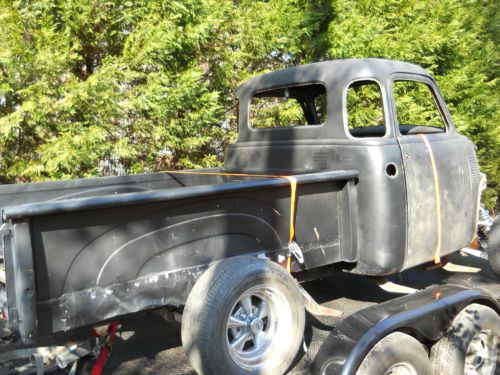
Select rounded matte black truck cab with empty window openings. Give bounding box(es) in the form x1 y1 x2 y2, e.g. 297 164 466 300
224 59 480 275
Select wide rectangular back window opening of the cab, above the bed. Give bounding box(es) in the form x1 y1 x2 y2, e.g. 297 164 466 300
249 83 328 129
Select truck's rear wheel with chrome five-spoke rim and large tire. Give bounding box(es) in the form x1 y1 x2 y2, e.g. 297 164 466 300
181 256 305 375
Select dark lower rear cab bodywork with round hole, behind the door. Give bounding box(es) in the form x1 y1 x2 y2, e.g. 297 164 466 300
225 138 406 275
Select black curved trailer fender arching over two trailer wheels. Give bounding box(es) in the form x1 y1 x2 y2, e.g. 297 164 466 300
312 285 500 375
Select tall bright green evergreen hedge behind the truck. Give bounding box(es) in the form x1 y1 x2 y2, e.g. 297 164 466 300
0 0 500 207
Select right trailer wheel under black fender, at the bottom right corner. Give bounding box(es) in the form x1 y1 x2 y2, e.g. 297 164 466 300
431 303 500 375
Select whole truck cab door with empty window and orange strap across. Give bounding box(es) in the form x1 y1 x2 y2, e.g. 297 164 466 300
392 74 475 268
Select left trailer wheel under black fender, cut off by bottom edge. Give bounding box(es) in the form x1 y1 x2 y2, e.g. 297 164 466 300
356 332 431 375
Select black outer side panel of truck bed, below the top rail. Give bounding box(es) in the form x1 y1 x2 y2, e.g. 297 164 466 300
16 181 351 334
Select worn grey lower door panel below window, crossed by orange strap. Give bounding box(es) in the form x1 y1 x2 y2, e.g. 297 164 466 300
400 134 478 268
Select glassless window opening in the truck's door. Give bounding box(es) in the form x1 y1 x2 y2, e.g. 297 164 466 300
393 80 447 135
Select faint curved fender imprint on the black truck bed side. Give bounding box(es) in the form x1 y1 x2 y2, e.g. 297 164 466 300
63 212 288 292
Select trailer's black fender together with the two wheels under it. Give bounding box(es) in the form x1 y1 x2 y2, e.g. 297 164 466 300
311 280 500 375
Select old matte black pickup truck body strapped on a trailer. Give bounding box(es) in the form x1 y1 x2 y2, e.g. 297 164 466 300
0 59 498 374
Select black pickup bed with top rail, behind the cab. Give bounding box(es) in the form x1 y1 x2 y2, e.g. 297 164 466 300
0 170 357 341
